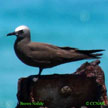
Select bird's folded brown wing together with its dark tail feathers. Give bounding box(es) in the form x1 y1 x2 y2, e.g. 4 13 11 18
28 43 103 63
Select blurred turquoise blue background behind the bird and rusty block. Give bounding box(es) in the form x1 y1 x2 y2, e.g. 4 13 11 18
0 0 108 108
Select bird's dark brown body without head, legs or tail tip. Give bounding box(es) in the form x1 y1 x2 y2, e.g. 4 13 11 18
14 39 102 68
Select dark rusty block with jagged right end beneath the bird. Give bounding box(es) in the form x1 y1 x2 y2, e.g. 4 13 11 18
16 60 107 108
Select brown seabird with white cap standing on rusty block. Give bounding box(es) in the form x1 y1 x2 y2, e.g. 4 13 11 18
7 25 104 76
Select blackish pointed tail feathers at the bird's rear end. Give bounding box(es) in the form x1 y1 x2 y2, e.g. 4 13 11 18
77 49 105 59
